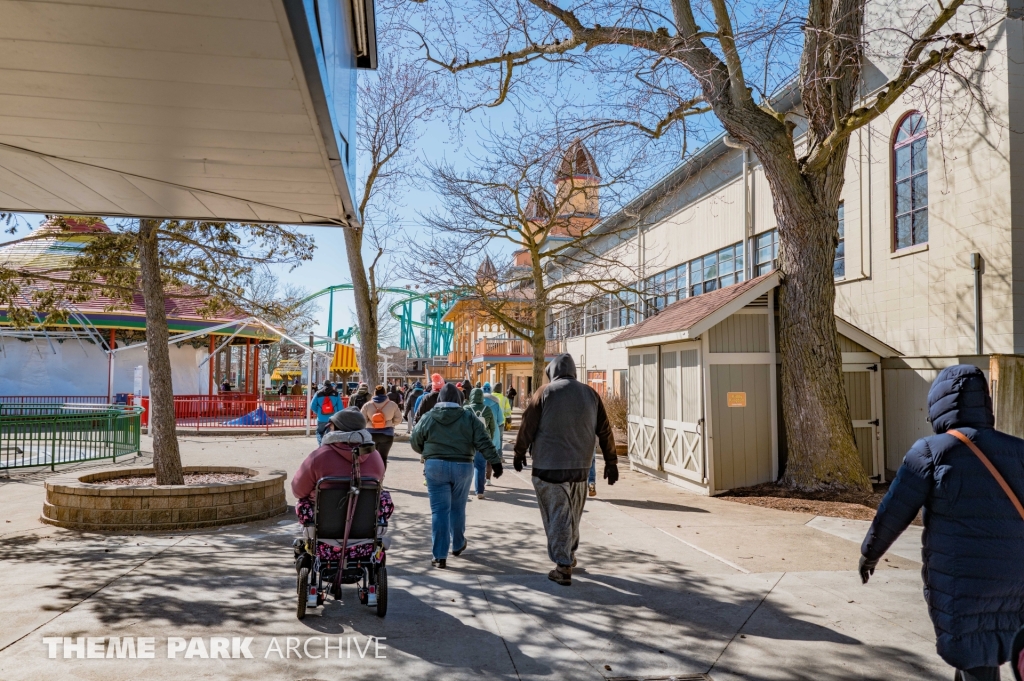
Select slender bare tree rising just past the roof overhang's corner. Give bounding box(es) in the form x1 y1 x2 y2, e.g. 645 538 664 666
345 56 437 385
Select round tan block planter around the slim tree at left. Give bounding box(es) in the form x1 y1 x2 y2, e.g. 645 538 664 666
40 466 287 533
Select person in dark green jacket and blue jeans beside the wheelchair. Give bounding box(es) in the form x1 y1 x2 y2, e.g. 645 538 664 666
410 384 502 567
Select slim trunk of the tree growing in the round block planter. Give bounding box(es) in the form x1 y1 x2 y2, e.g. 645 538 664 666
138 220 184 484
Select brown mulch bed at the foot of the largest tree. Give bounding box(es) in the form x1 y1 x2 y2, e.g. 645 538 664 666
719 482 921 525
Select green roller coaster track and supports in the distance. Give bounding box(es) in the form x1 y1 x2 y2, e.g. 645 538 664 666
302 284 455 357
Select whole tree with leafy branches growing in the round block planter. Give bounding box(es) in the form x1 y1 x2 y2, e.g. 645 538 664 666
0 217 313 484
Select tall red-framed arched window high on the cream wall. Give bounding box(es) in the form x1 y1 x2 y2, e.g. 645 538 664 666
893 112 928 250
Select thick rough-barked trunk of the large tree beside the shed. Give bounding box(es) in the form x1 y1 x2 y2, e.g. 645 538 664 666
772 168 870 490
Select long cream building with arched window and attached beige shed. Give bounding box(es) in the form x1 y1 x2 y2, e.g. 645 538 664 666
551 20 1024 494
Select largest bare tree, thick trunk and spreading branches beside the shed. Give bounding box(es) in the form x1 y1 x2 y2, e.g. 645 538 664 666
410 0 1006 487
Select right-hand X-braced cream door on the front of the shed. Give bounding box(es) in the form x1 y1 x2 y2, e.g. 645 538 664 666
662 342 706 483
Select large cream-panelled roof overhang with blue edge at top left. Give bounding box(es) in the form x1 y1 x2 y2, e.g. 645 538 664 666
0 0 376 225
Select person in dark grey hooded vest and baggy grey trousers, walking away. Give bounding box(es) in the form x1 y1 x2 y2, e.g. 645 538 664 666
513 353 618 586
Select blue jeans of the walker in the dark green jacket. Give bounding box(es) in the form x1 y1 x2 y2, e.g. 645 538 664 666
423 459 473 560
